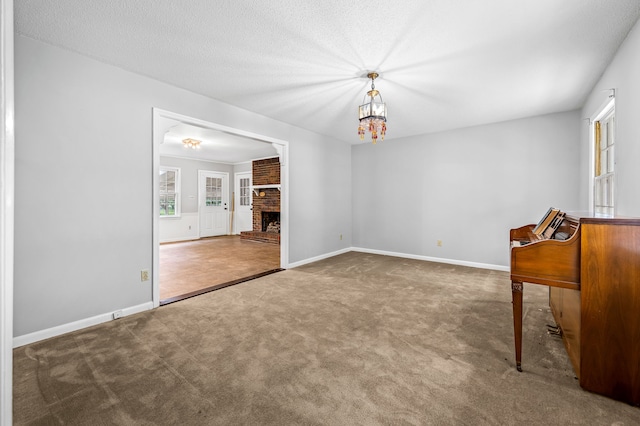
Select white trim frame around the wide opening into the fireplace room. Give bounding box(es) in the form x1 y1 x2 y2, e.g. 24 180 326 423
151 108 289 308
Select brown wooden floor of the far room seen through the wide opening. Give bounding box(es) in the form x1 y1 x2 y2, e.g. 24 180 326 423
160 235 280 304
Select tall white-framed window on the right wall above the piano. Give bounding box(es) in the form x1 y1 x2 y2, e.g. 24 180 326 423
593 105 616 216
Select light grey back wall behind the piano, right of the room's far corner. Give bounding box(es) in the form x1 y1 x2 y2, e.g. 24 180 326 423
352 111 580 267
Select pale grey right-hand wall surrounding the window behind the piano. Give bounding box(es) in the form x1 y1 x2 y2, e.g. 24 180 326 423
580 17 640 217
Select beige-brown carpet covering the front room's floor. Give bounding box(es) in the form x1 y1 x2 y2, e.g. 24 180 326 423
14 253 640 425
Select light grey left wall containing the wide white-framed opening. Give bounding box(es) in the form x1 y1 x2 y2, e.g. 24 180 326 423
14 36 351 337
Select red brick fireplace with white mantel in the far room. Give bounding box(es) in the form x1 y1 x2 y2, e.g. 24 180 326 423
240 157 280 244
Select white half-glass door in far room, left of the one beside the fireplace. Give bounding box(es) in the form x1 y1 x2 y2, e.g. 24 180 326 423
198 170 229 238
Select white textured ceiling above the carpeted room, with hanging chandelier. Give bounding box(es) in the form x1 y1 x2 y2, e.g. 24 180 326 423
15 0 640 143
